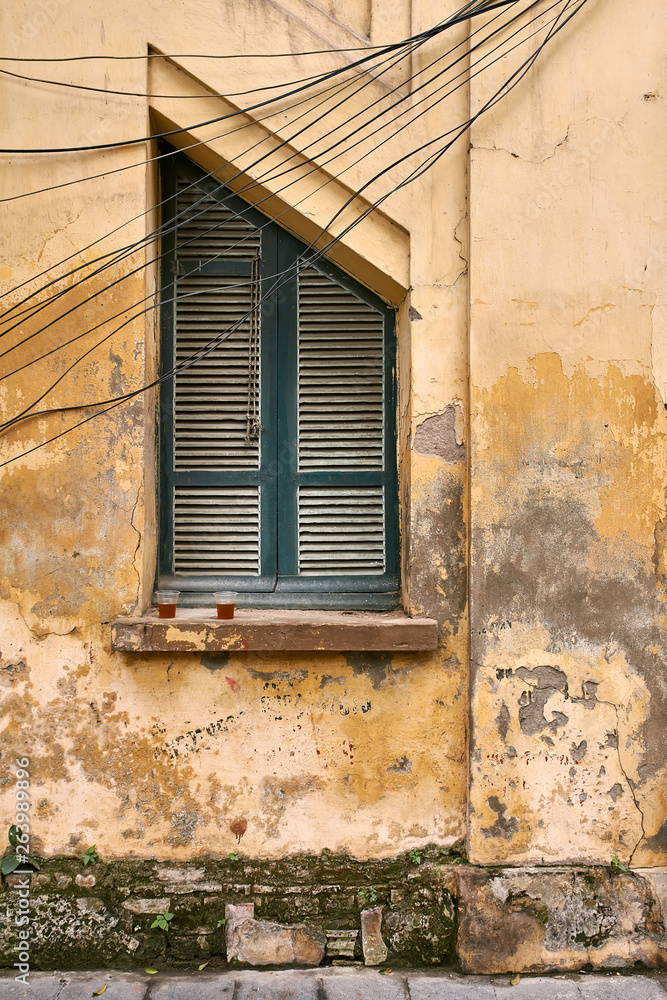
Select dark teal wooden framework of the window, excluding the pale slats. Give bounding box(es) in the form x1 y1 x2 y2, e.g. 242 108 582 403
156 152 400 610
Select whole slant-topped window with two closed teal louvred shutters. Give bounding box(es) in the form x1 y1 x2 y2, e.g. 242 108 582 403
158 155 398 609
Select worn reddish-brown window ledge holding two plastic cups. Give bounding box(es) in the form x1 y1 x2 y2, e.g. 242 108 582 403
111 608 438 653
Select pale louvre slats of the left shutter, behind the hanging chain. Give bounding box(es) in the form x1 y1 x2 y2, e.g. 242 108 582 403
173 179 261 576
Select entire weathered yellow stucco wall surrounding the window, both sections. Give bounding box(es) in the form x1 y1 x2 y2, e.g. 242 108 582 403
0 0 667 865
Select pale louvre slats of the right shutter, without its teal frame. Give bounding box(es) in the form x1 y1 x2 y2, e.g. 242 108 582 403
297 267 386 576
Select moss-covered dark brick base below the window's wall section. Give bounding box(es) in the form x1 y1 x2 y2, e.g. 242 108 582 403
0 848 459 969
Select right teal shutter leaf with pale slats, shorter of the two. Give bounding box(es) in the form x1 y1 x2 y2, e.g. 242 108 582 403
278 233 398 607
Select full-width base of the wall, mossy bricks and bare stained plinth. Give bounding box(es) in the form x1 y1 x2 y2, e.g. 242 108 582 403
0 848 667 973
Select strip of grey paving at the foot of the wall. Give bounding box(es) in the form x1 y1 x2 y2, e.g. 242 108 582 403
0 968 667 1000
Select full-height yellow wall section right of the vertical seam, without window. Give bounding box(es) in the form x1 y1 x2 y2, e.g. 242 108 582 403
470 0 667 866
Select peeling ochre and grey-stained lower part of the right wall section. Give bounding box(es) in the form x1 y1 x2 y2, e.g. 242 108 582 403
471 356 667 864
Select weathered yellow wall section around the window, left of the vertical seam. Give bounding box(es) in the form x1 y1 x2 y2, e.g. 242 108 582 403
0 0 468 859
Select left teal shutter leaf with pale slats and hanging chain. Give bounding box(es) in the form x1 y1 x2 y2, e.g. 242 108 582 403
162 161 275 592
